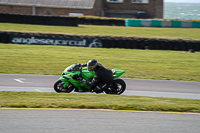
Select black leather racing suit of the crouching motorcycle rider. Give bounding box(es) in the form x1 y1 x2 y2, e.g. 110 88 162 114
86 64 113 93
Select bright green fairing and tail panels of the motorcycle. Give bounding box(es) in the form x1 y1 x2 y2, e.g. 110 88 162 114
60 63 125 92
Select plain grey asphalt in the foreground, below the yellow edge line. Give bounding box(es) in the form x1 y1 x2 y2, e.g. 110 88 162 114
0 109 200 133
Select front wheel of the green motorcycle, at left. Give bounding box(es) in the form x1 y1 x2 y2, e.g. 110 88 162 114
54 80 74 93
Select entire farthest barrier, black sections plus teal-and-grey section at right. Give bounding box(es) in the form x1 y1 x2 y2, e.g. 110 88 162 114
0 13 200 28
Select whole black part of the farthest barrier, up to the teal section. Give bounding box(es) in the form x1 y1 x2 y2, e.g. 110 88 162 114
0 13 125 26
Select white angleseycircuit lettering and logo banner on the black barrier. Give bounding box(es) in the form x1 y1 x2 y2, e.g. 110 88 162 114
10 34 103 47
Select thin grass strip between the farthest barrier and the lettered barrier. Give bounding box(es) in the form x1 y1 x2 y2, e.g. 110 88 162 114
0 23 200 39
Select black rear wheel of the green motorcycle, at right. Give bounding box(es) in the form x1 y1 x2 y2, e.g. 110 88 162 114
104 79 126 95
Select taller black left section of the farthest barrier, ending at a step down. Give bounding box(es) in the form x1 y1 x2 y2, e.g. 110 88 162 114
0 13 78 26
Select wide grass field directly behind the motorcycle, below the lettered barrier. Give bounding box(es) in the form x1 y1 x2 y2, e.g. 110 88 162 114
0 44 200 81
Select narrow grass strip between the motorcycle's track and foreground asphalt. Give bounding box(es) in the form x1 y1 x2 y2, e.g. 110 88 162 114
0 92 200 113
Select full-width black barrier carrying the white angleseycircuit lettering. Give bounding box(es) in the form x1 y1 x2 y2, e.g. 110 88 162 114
0 32 200 51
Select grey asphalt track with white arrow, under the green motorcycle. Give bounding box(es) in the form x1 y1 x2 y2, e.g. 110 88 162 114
0 74 200 99
